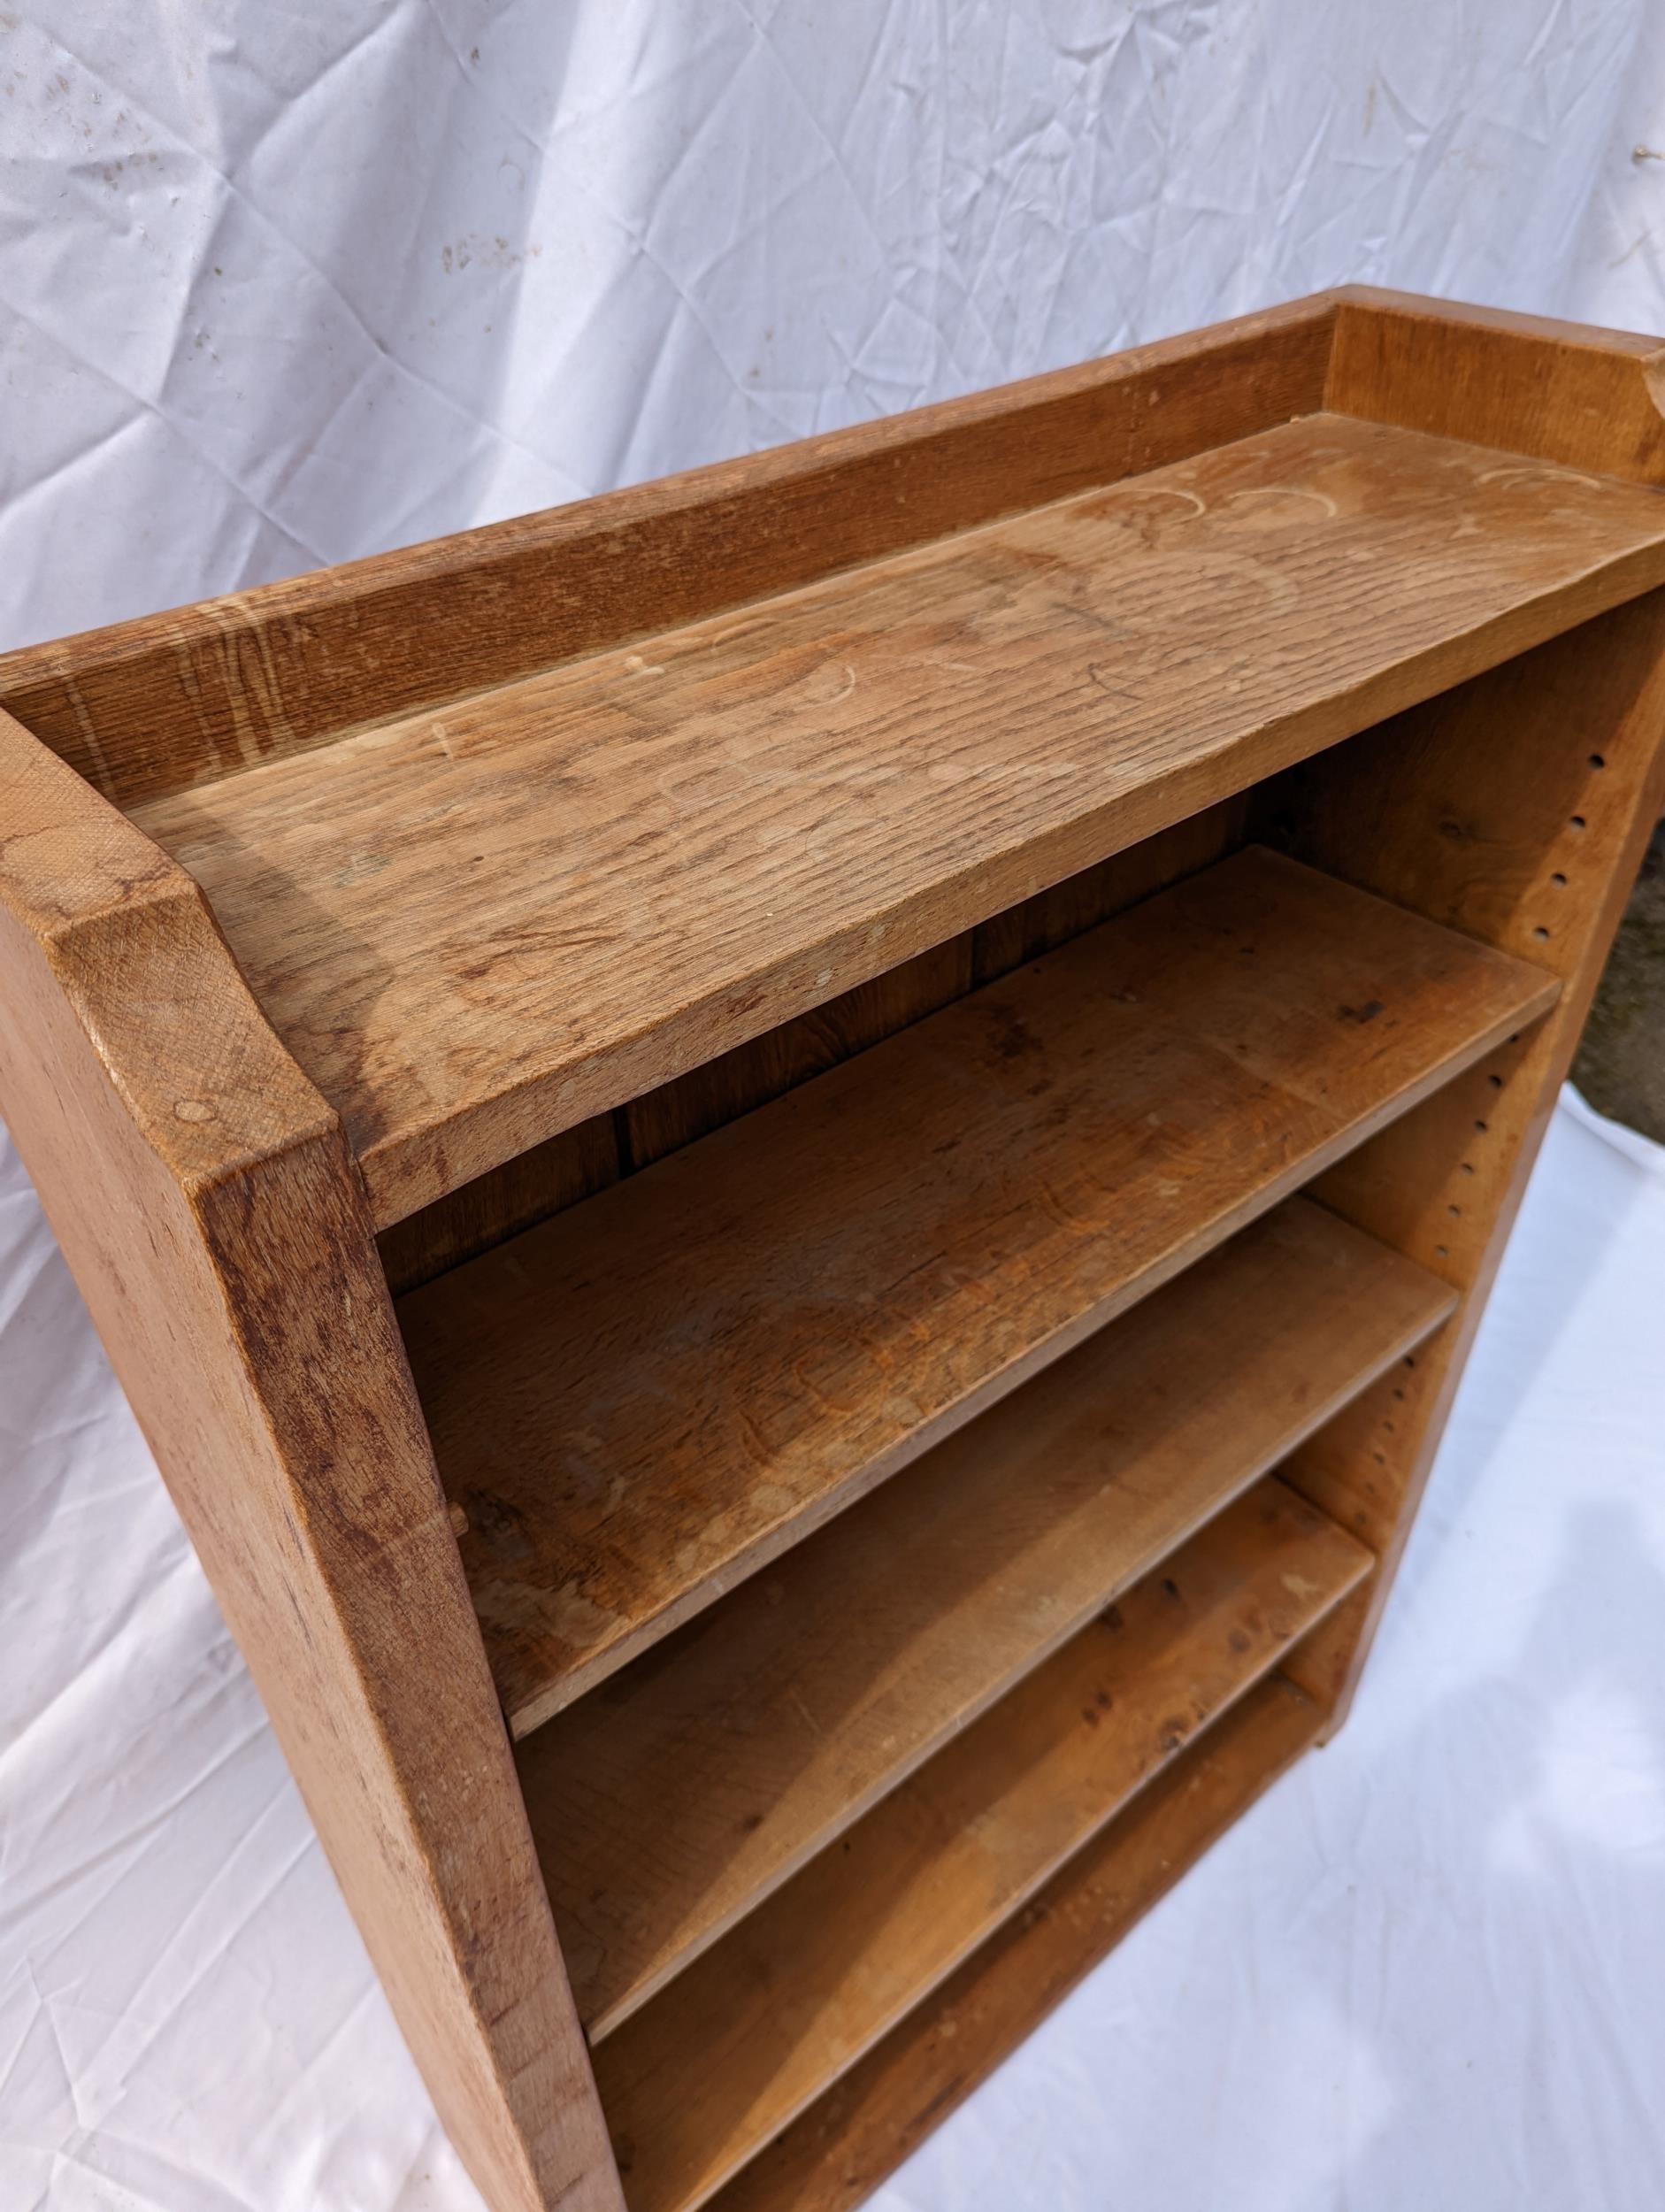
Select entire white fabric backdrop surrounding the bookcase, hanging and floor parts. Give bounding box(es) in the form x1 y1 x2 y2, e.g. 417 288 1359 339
0 12 1665 2212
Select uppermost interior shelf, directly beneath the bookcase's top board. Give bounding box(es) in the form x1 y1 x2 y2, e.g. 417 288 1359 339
400 849 1557 1734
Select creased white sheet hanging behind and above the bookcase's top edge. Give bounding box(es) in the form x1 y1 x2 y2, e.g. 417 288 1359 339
0 0 1665 646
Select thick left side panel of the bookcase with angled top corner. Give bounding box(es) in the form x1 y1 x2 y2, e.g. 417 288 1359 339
0 715 621 2212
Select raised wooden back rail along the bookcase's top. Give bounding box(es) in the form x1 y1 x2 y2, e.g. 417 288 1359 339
0 299 1333 808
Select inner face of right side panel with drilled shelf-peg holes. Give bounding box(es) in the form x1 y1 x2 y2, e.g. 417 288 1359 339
1261 593 1665 1719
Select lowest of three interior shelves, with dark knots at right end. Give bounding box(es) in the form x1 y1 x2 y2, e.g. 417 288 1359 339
595 1480 1371 2212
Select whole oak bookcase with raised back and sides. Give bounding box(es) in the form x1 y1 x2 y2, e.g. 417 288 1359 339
0 290 1665 2212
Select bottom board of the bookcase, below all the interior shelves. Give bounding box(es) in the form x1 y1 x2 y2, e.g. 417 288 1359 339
712 1675 1323 2212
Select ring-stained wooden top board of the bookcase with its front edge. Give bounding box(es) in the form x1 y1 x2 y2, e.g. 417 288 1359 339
133 414 1665 1225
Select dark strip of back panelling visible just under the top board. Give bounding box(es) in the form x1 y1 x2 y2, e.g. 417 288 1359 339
378 795 1247 1294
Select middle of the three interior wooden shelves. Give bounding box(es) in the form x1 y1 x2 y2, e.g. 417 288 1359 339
519 1199 1455 2039
